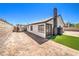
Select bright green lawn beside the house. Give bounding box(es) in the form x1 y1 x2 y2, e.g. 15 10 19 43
50 35 79 50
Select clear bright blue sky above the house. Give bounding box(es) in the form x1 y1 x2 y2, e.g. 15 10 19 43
0 3 79 25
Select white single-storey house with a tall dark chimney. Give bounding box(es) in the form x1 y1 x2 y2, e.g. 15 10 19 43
27 8 64 38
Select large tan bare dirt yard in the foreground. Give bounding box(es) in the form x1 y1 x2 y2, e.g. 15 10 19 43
0 32 79 56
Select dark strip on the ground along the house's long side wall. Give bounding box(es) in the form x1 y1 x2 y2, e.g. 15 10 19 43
24 32 48 44
